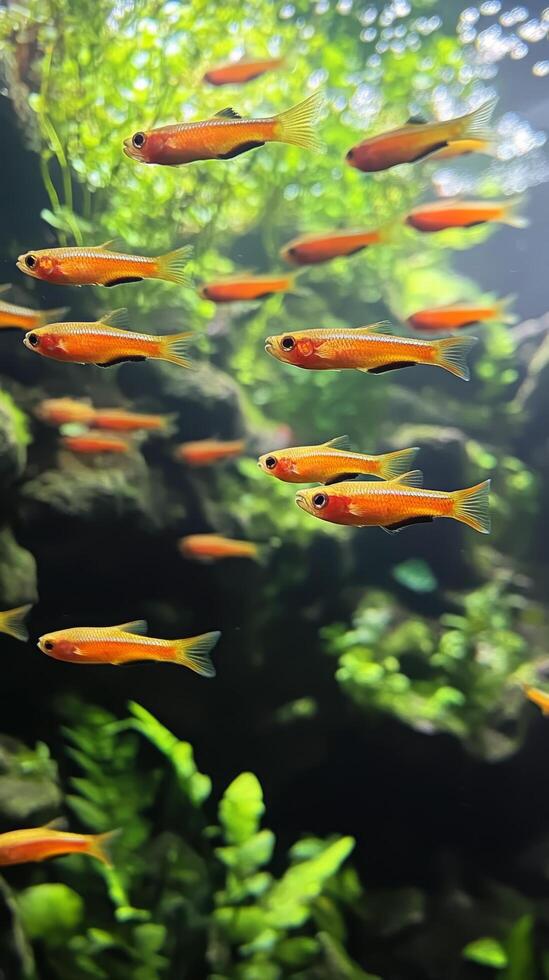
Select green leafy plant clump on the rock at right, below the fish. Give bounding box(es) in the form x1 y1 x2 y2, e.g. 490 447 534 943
323 583 548 759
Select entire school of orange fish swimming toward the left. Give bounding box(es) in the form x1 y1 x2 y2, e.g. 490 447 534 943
0 53 536 865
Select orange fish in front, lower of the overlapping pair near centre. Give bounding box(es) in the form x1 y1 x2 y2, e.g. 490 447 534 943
295 470 490 534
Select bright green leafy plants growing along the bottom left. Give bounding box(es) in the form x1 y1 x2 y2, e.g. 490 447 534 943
5 699 368 980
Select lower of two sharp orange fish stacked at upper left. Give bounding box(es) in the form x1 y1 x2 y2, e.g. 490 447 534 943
23 309 192 367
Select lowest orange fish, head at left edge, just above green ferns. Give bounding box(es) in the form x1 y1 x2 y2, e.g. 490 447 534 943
0 825 119 867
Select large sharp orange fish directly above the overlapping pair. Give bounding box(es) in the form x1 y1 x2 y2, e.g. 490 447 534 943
265 323 476 381
